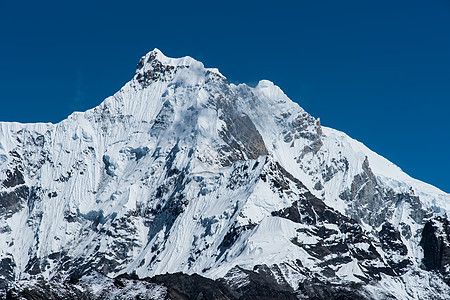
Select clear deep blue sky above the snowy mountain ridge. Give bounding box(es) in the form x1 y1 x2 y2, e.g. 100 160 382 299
0 0 450 192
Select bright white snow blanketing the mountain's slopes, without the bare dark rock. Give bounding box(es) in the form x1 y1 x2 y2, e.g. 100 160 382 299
0 49 450 299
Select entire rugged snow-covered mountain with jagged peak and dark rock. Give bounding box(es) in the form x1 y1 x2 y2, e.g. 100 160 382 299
0 49 450 299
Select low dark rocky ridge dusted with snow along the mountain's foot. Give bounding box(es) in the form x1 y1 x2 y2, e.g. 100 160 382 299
6 266 368 300
